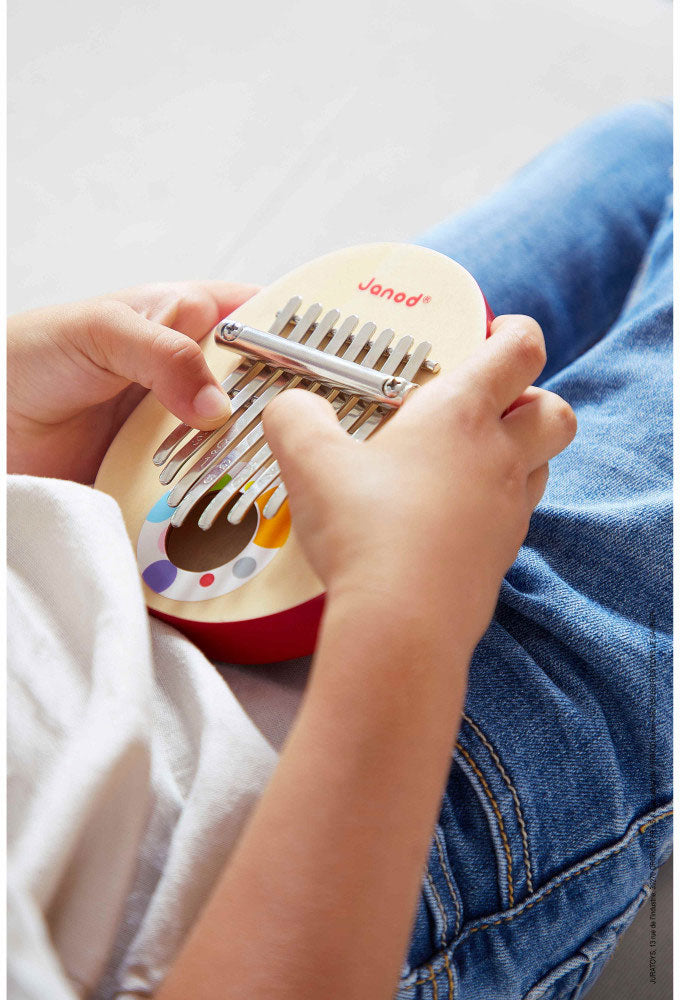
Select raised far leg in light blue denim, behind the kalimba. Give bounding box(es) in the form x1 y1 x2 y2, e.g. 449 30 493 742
416 102 673 380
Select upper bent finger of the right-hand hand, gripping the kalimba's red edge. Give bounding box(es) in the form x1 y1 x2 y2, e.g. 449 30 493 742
463 316 546 416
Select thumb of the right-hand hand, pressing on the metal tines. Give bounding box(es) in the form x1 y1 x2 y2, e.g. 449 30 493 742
262 389 348 502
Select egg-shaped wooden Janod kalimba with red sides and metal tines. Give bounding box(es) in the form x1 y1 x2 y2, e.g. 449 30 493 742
95 243 492 663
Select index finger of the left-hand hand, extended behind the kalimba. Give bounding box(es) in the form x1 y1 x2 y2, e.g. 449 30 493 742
100 281 259 340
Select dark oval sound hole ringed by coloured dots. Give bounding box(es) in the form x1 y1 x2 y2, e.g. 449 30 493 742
165 492 257 573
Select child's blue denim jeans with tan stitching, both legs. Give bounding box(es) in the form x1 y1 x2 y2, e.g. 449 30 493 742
397 103 672 1000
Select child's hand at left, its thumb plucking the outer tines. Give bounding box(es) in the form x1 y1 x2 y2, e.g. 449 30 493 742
7 281 257 483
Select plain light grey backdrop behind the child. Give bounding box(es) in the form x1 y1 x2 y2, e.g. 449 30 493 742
8 0 671 1000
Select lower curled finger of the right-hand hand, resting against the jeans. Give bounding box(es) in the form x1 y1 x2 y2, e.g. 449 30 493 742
503 389 576 469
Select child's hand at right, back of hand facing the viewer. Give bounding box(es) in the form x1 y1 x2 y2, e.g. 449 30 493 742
264 316 576 653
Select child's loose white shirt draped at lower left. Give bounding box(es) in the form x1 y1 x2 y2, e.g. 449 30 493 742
8 476 304 1000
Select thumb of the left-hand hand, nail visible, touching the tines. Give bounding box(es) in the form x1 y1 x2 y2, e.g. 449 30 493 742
81 301 231 430
